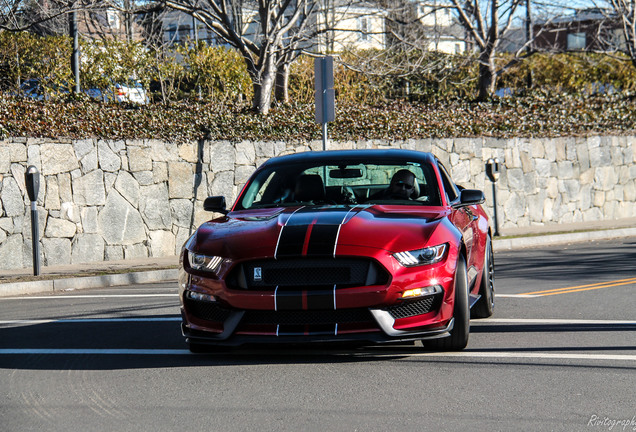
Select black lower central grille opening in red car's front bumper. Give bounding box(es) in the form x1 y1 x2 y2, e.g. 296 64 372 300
241 309 373 325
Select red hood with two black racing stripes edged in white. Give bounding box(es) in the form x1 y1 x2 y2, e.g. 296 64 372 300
187 205 448 259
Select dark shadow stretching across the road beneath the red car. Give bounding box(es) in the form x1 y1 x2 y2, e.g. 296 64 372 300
0 315 636 370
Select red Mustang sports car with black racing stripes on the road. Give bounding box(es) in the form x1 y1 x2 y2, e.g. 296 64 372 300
180 150 494 352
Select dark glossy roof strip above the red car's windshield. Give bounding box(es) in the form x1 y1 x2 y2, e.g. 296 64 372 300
262 149 435 168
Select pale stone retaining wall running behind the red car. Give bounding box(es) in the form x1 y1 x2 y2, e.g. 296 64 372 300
0 137 636 269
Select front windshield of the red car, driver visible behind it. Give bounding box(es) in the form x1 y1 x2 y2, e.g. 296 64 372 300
236 162 441 210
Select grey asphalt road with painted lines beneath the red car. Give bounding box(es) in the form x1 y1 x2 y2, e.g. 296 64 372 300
0 238 636 432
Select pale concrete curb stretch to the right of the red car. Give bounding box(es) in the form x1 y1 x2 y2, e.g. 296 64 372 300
493 228 636 251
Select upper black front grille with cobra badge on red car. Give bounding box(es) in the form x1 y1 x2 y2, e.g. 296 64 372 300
227 258 389 290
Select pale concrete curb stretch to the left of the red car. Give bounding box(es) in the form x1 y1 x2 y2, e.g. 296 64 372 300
0 269 179 297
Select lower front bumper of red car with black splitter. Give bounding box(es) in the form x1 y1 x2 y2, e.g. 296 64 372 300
181 294 453 346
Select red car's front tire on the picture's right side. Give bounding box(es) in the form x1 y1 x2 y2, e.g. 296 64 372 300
423 255 470 351
